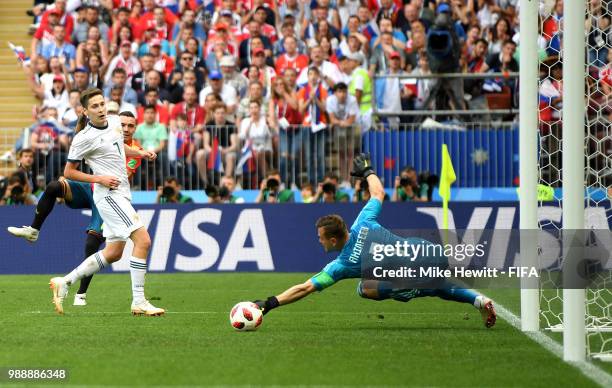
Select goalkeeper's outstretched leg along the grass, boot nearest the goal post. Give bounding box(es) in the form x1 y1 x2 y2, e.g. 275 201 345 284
357 280 497 328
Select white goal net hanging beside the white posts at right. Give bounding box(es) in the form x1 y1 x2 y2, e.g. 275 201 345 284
538 1 612 361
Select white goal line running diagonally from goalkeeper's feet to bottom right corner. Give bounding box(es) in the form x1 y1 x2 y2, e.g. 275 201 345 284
495 302 612 387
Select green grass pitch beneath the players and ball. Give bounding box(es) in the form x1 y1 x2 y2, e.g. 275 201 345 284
0 274 594 387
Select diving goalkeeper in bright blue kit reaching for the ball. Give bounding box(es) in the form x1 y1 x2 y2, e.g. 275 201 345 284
255 154 497 328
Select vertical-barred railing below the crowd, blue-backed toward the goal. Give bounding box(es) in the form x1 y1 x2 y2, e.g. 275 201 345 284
0 121 518 190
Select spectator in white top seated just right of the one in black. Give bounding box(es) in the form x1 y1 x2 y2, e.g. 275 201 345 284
239 99 274 180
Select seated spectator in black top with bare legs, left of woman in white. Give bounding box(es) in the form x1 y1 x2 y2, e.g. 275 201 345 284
196 103 239 182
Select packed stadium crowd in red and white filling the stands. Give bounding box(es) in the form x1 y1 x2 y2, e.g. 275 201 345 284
1 0 588 205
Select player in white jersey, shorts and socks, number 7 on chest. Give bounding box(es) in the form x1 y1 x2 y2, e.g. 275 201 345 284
49 88 165 316
